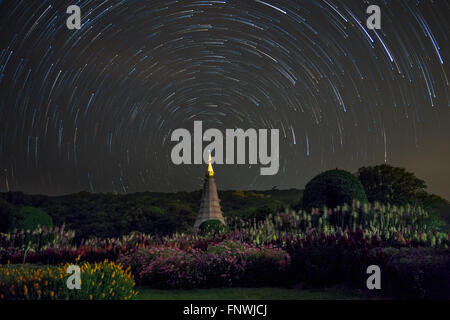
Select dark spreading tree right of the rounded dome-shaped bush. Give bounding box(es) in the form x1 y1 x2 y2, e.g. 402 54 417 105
358 164 426 205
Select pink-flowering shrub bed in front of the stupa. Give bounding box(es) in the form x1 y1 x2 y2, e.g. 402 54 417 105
124 241 290 288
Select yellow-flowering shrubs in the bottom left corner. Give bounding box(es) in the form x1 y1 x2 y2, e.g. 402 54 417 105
0 261 137 300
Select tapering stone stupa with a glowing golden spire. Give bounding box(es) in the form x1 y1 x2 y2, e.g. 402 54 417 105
194 152 225 230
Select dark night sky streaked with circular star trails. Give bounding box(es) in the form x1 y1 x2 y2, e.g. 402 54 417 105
0 0 450 198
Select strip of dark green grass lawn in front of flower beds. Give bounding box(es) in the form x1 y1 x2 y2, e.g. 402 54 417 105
136 287 362 300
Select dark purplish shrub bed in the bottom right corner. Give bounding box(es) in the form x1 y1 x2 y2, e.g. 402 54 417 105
288 239 450 299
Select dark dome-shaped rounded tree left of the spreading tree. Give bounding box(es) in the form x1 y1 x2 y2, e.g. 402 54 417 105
303 169 367 211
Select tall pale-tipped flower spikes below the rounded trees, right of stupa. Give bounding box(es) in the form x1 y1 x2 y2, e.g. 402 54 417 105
227 202 450 248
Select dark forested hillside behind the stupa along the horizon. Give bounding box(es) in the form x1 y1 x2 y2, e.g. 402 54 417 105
0 189 301 243
